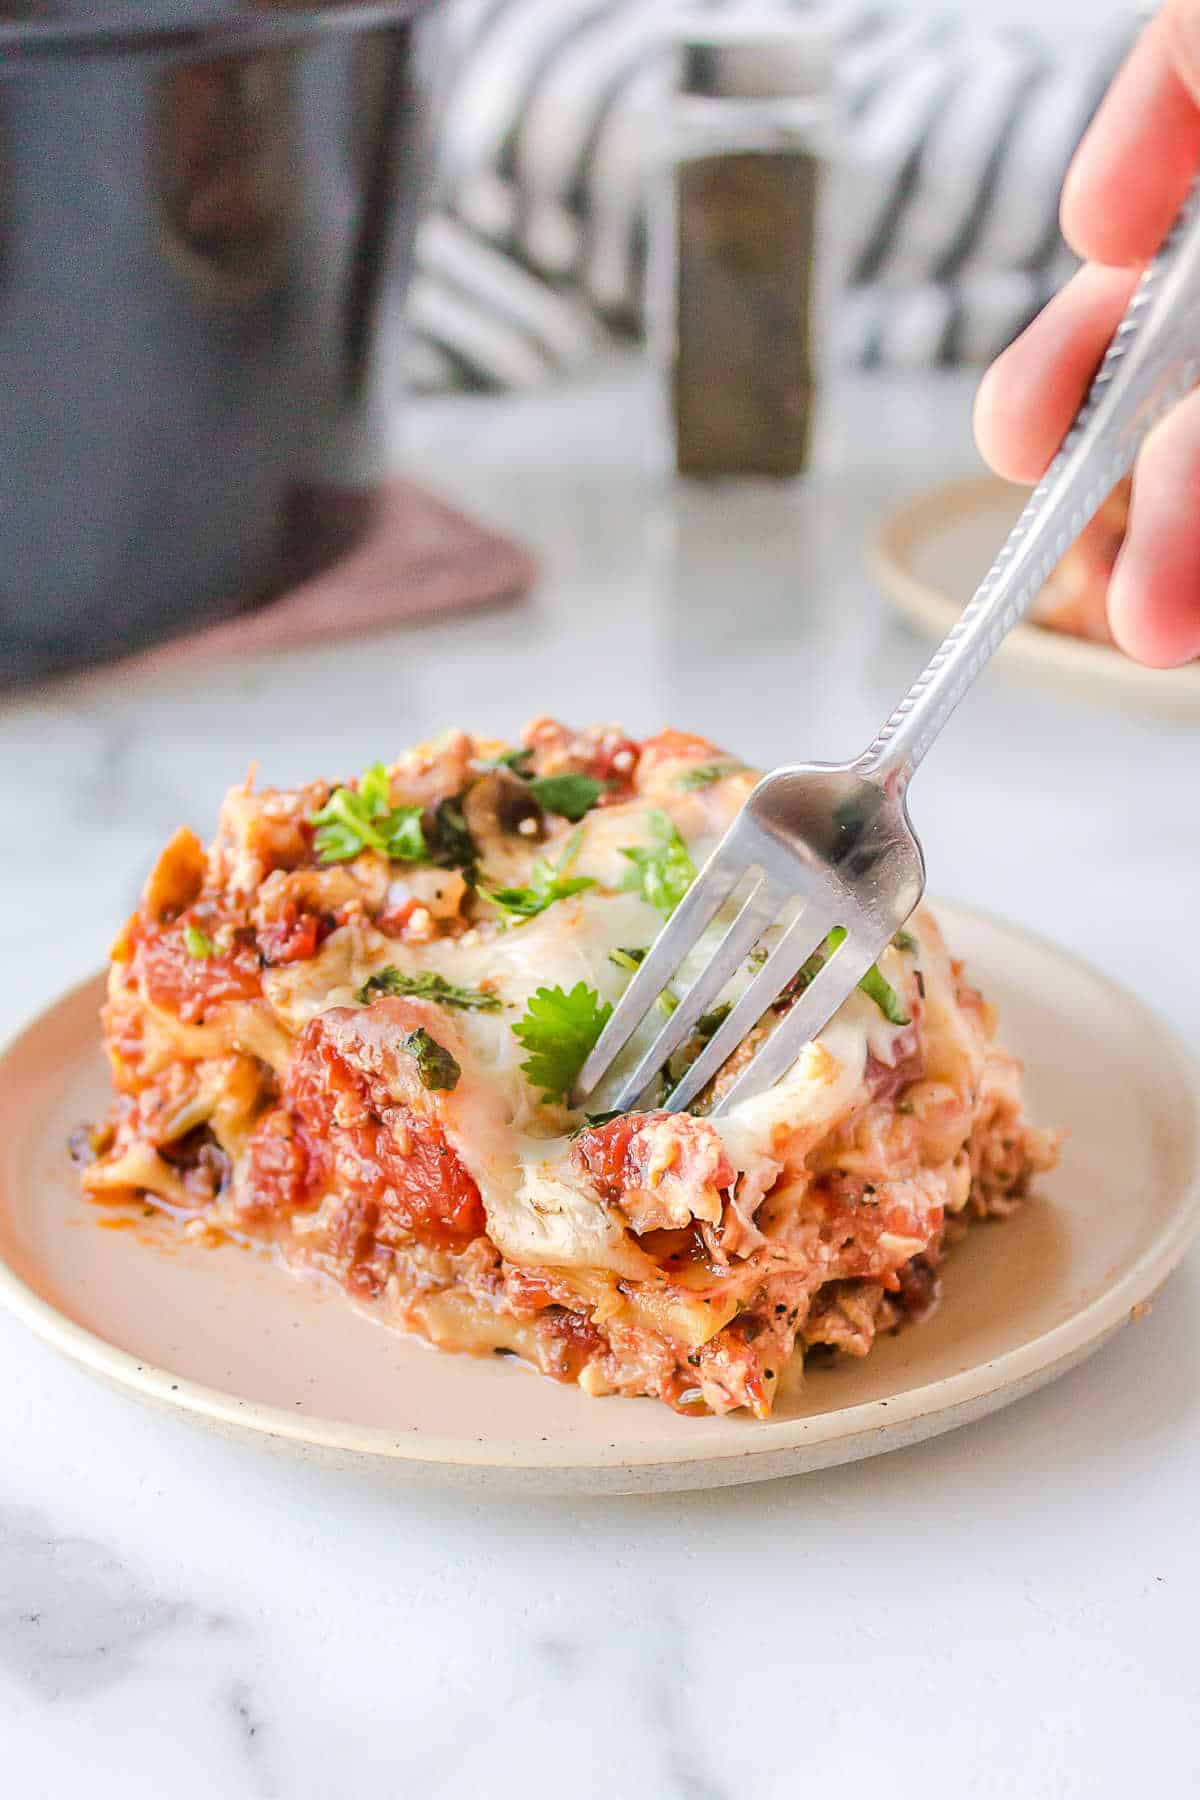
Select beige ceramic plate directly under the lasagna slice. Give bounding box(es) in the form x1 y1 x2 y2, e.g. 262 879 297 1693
0 907 1200 1492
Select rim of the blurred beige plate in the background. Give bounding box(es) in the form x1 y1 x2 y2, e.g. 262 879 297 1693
867 475 1200 709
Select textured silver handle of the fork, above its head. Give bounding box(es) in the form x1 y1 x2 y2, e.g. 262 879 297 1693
855 176 1200 794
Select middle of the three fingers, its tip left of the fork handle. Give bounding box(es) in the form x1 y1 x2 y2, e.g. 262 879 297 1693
975 265 1137 481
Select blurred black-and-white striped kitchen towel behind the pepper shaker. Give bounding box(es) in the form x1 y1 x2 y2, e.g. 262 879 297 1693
407 0 1137 389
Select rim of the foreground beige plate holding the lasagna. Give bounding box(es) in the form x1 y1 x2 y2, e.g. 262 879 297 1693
0 900 1200 1490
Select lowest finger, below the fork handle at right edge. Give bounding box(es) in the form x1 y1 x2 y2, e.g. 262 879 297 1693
1108 392 1200 668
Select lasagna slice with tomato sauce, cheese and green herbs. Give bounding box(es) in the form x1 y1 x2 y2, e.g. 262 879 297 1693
83 720 1052 1418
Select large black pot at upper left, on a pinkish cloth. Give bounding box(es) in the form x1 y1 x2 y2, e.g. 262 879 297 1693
0 0 444 682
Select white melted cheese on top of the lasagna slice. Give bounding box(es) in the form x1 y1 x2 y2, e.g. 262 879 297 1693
116 781 949 1283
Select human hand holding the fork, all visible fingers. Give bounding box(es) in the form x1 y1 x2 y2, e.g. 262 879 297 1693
975 0 1200 668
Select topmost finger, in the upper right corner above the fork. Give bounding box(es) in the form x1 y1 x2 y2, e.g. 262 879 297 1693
1061 0 1200 268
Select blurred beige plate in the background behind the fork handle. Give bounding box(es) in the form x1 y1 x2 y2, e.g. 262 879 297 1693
871 475 1200 713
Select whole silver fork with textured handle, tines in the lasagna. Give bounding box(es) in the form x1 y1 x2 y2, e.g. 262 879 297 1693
576 180 1200 1112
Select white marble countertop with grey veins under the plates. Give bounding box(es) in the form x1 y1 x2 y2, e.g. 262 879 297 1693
0 367 1200 1800
